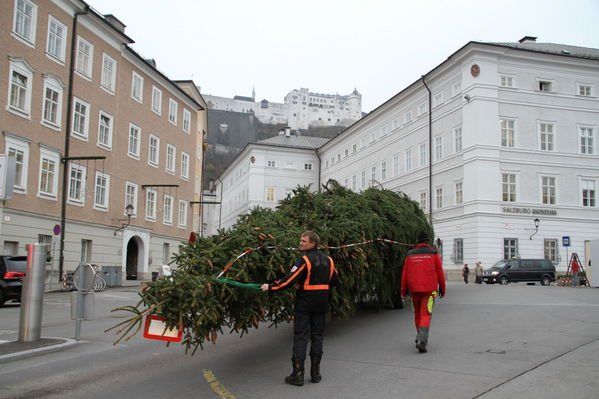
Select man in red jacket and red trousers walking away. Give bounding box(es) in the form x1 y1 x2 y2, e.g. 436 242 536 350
401 232 445 353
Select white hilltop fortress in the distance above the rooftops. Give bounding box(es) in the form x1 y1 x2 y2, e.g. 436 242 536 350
204 88 362 130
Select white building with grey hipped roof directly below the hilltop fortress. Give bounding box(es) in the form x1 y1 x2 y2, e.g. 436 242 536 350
204 133 328 235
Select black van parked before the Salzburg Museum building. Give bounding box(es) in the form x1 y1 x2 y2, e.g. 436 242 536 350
483 259 555 285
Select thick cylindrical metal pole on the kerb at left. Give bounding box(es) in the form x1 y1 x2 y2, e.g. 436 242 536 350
19 244 46 342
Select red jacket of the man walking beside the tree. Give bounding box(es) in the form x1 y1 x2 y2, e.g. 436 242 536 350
401 244 445 296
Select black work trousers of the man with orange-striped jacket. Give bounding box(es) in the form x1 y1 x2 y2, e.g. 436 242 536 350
293 309 326 364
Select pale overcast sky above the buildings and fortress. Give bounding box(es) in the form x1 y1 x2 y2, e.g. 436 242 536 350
95 0 599 112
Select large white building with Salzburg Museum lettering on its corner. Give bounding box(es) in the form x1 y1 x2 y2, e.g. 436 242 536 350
318 37 599 270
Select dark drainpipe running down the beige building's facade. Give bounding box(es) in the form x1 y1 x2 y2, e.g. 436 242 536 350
58 4 89 281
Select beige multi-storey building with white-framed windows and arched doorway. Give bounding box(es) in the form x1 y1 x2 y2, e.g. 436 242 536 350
0 0 207 288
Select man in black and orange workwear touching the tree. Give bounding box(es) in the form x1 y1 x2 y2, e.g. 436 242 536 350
261 231 339 386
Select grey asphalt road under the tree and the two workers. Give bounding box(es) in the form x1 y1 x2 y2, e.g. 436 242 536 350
0 283 599 399
